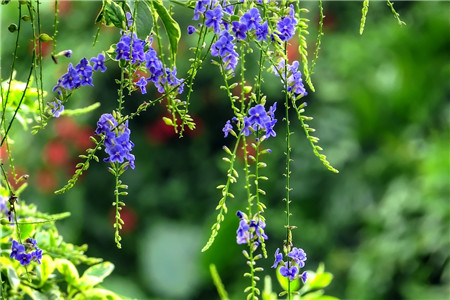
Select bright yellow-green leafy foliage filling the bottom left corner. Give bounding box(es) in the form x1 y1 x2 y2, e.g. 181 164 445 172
0 198 121 299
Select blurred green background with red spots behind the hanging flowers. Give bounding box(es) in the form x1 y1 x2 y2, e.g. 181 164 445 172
1 1 450 299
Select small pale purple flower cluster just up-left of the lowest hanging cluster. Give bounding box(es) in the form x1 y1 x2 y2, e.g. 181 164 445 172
236 210 268 246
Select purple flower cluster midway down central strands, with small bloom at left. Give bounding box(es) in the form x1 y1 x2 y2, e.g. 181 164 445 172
222 102 277 138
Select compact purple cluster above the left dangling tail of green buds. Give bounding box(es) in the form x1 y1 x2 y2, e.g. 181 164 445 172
95 114 135 169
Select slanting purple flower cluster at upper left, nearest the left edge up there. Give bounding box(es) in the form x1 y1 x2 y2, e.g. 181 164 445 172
47 50 106 118
